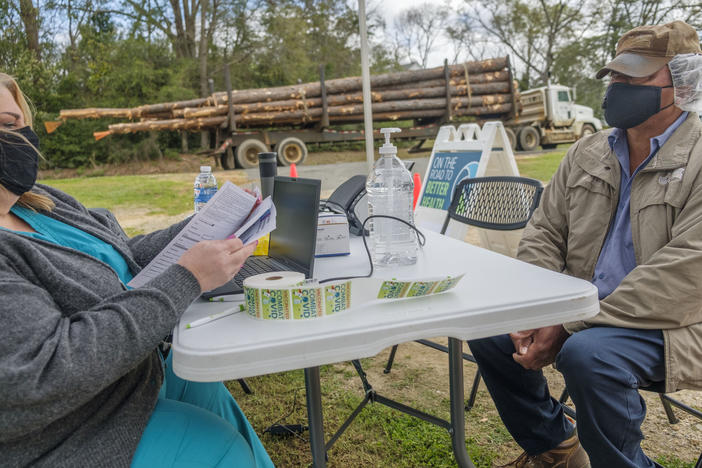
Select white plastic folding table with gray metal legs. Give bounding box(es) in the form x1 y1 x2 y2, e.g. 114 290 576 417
172 232 599 467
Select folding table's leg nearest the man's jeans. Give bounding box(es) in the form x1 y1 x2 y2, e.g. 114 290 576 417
449 338 475 468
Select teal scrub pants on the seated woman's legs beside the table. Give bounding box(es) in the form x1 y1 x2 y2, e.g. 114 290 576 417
132 356 273 468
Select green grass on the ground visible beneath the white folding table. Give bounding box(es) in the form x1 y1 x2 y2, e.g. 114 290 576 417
234 359 502 468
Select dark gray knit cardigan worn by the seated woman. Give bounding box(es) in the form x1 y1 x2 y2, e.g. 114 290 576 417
0 185 200 467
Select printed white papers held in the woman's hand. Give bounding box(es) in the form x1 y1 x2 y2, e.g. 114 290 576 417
127 182 276 288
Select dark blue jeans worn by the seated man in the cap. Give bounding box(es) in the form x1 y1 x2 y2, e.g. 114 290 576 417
468 327 665 468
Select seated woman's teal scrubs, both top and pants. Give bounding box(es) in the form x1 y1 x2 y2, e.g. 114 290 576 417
11 207 273 468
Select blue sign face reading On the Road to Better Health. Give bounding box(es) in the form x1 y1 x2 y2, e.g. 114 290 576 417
419 151 482 210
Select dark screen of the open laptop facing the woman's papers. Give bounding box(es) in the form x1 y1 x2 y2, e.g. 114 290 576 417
268 176 321 278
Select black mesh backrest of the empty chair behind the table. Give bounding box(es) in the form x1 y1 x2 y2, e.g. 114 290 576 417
441 176 543 234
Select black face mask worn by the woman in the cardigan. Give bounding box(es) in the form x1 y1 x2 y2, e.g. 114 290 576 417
0 127 39 195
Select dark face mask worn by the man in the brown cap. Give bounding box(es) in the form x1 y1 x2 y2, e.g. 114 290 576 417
602 83 673 130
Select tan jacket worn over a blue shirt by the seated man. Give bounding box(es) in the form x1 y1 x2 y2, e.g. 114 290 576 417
517 113 702 392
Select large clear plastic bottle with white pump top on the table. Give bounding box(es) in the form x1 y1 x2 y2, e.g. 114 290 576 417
366 128 417 266
